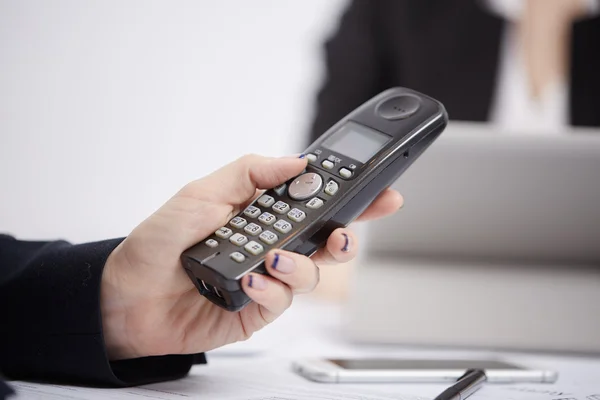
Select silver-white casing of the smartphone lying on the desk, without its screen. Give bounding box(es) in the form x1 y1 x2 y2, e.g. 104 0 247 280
293 359 558 383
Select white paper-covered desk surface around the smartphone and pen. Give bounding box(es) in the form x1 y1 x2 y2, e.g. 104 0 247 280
12 298 600 400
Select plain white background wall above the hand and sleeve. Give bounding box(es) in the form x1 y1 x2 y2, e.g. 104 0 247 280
0 0 345 242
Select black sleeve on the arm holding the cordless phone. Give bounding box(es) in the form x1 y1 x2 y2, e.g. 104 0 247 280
0 235 205 387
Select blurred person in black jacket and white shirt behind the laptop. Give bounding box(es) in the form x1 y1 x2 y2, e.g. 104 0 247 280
310 0 600 142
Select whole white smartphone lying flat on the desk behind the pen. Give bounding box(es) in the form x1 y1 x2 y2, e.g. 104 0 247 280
293 359 558 383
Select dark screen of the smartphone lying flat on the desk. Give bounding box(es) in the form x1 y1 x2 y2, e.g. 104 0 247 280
329 359 524 370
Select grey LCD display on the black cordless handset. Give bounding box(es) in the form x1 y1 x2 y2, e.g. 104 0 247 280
323 121 391 163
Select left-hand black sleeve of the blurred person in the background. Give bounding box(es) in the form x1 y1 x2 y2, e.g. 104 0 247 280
308 0 388 144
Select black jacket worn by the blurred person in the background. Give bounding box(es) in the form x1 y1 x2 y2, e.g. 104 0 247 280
310 0 600 142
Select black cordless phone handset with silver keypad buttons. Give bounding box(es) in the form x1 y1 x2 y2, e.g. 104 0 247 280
182 88 448 311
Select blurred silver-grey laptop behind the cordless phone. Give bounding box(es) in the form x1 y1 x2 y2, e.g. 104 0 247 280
344 122 600 353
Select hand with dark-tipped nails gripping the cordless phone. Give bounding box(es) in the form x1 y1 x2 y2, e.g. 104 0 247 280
100 155 403 360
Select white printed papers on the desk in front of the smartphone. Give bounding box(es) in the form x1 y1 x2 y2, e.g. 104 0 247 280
11 357 600 400
